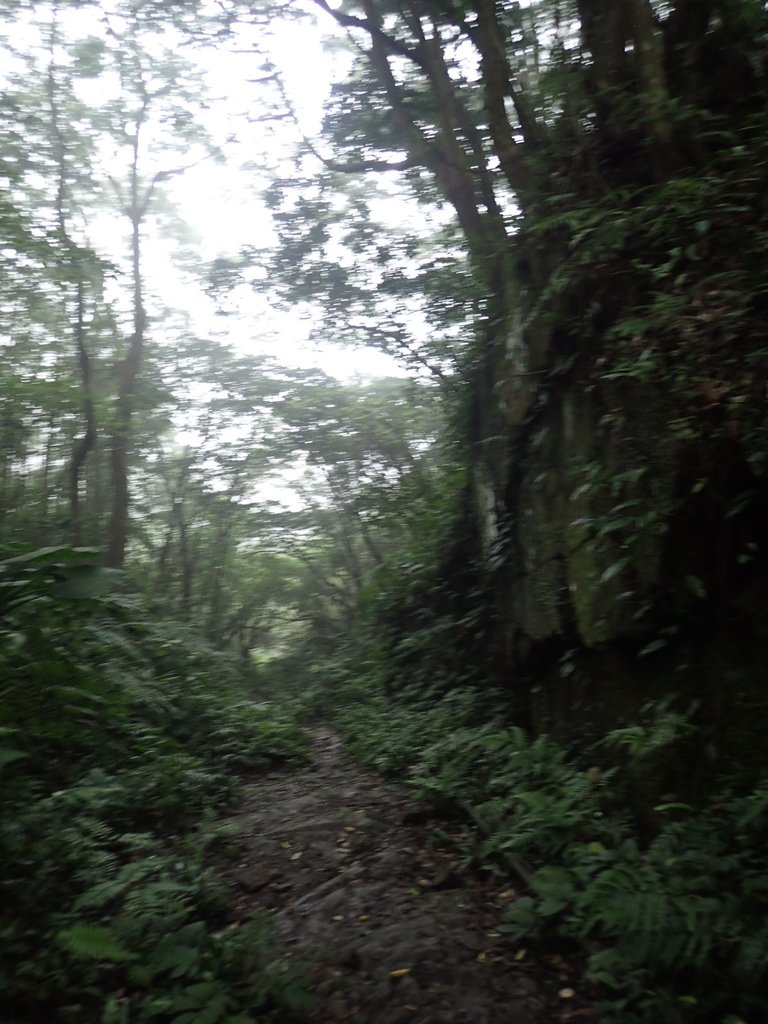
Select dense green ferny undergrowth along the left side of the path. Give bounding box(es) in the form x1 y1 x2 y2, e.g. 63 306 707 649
0 549 313 1024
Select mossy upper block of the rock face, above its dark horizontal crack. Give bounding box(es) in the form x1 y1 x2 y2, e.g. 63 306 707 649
473 276 768 643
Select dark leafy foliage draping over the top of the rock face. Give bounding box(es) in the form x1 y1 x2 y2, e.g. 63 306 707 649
529 115 768 464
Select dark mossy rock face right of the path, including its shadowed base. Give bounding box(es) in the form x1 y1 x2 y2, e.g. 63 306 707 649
474 280 768 753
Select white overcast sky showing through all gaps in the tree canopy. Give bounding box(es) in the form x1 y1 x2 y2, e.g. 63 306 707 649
0 0 421 504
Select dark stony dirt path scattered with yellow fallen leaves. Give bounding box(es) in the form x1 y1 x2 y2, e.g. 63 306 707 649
218 727 599 1024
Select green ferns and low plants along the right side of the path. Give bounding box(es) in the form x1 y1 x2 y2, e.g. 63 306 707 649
339 690 768 1024
